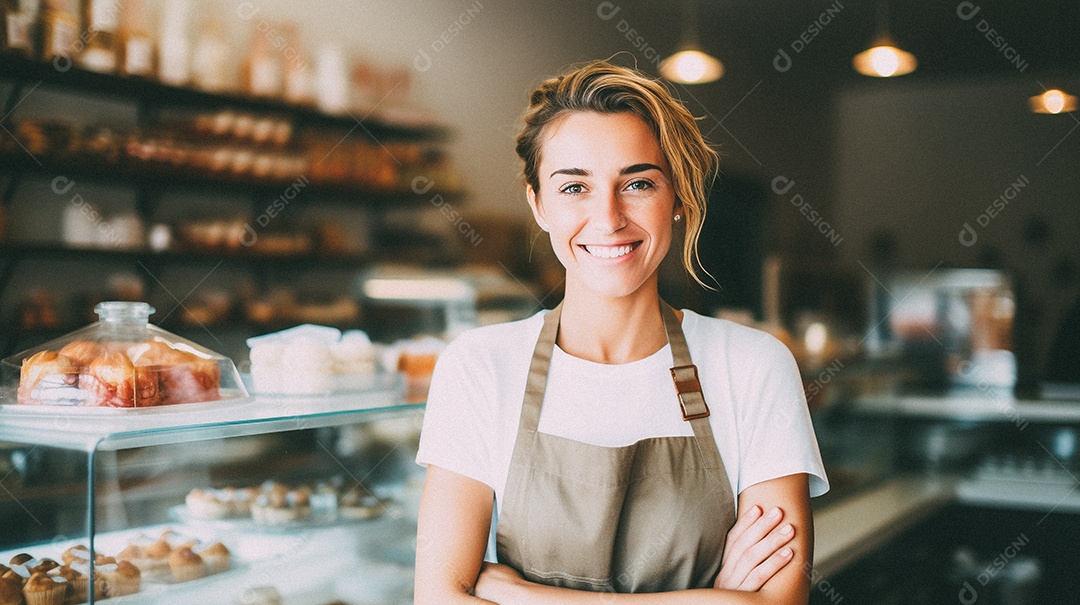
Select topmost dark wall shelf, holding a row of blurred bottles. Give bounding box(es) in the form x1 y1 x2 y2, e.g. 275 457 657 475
0 54 450 140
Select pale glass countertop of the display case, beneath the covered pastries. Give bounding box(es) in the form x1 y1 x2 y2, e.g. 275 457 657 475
0 382 423 452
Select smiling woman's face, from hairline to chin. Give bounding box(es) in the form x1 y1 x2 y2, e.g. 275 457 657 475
527 111 676 297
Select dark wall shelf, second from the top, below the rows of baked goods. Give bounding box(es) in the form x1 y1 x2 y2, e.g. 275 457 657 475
0 150 464 206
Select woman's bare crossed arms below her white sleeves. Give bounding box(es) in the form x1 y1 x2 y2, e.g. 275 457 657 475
416 466 813 605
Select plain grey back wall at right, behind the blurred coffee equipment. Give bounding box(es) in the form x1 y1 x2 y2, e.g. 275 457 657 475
833 77 1080 378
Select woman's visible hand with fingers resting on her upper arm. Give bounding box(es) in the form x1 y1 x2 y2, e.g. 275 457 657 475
714 506 795 591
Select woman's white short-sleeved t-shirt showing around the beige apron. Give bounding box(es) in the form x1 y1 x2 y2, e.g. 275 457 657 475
417 310 828 512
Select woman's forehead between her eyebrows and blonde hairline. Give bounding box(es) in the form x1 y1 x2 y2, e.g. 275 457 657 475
540 111 667 171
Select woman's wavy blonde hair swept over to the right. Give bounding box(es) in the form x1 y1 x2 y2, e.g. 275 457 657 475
516 61 719 287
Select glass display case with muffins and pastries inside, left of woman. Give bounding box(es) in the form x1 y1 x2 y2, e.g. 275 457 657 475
0 385 422 605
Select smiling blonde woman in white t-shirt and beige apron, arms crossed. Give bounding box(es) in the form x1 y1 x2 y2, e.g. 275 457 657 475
416 62 827 605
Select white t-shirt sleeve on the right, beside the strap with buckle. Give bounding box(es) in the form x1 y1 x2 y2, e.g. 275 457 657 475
738 336 828 497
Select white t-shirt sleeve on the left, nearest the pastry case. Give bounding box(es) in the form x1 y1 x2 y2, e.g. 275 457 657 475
416 335 495 486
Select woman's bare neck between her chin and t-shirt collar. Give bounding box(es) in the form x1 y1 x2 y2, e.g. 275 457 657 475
557 274 667 364
